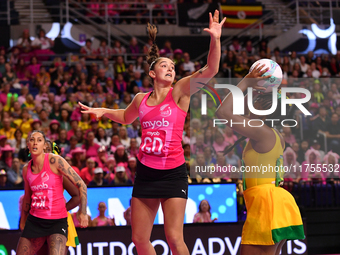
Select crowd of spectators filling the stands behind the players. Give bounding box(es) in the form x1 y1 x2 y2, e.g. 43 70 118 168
0 27 340 220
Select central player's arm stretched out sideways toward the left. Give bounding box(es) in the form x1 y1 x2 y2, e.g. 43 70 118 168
78 93 146 125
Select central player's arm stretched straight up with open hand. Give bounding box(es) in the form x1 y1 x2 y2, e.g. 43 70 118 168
173 10 226 98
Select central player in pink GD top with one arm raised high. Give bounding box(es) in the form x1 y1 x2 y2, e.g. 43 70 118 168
79 10 225 255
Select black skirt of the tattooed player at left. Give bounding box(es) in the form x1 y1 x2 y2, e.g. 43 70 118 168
21 214 68 238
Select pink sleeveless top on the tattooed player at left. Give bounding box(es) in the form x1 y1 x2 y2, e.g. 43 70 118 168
27 153 67 219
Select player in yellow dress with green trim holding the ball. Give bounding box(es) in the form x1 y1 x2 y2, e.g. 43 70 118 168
216 65 304 255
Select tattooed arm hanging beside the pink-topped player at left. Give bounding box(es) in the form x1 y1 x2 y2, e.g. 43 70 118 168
49 154 88 227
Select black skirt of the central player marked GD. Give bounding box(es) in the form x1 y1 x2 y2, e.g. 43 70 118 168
132 159 188 199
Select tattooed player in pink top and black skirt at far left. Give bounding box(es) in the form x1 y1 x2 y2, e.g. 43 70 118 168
16 131 88 255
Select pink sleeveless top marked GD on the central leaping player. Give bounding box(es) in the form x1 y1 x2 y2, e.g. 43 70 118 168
137 88 187 170
